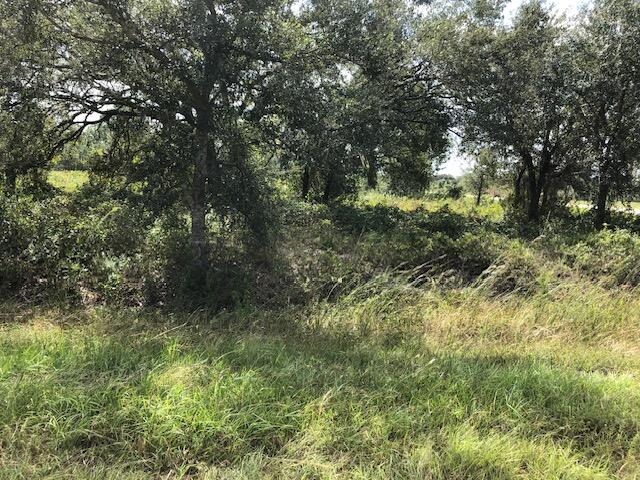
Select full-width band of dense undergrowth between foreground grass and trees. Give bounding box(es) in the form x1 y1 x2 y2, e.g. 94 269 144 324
5 176 640 309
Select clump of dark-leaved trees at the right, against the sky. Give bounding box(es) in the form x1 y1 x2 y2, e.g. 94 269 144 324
431 1 640 227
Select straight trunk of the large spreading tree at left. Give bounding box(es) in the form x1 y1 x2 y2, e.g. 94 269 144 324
191 122 209 274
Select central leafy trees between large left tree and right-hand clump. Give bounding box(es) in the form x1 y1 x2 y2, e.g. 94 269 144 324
274 0 449 199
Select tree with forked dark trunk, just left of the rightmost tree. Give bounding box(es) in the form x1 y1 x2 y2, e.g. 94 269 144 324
430 0 574 221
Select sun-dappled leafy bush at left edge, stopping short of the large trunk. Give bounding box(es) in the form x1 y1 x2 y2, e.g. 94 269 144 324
0 193 146 300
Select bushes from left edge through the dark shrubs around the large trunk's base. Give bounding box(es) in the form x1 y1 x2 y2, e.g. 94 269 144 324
0 189 272 309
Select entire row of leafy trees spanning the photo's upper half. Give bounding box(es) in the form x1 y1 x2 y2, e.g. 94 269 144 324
0 0 640 302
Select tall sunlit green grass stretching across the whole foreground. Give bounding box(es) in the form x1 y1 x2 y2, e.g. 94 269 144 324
0 282 640 479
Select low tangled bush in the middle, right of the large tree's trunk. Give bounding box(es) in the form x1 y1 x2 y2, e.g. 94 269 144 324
284 199 508 298
